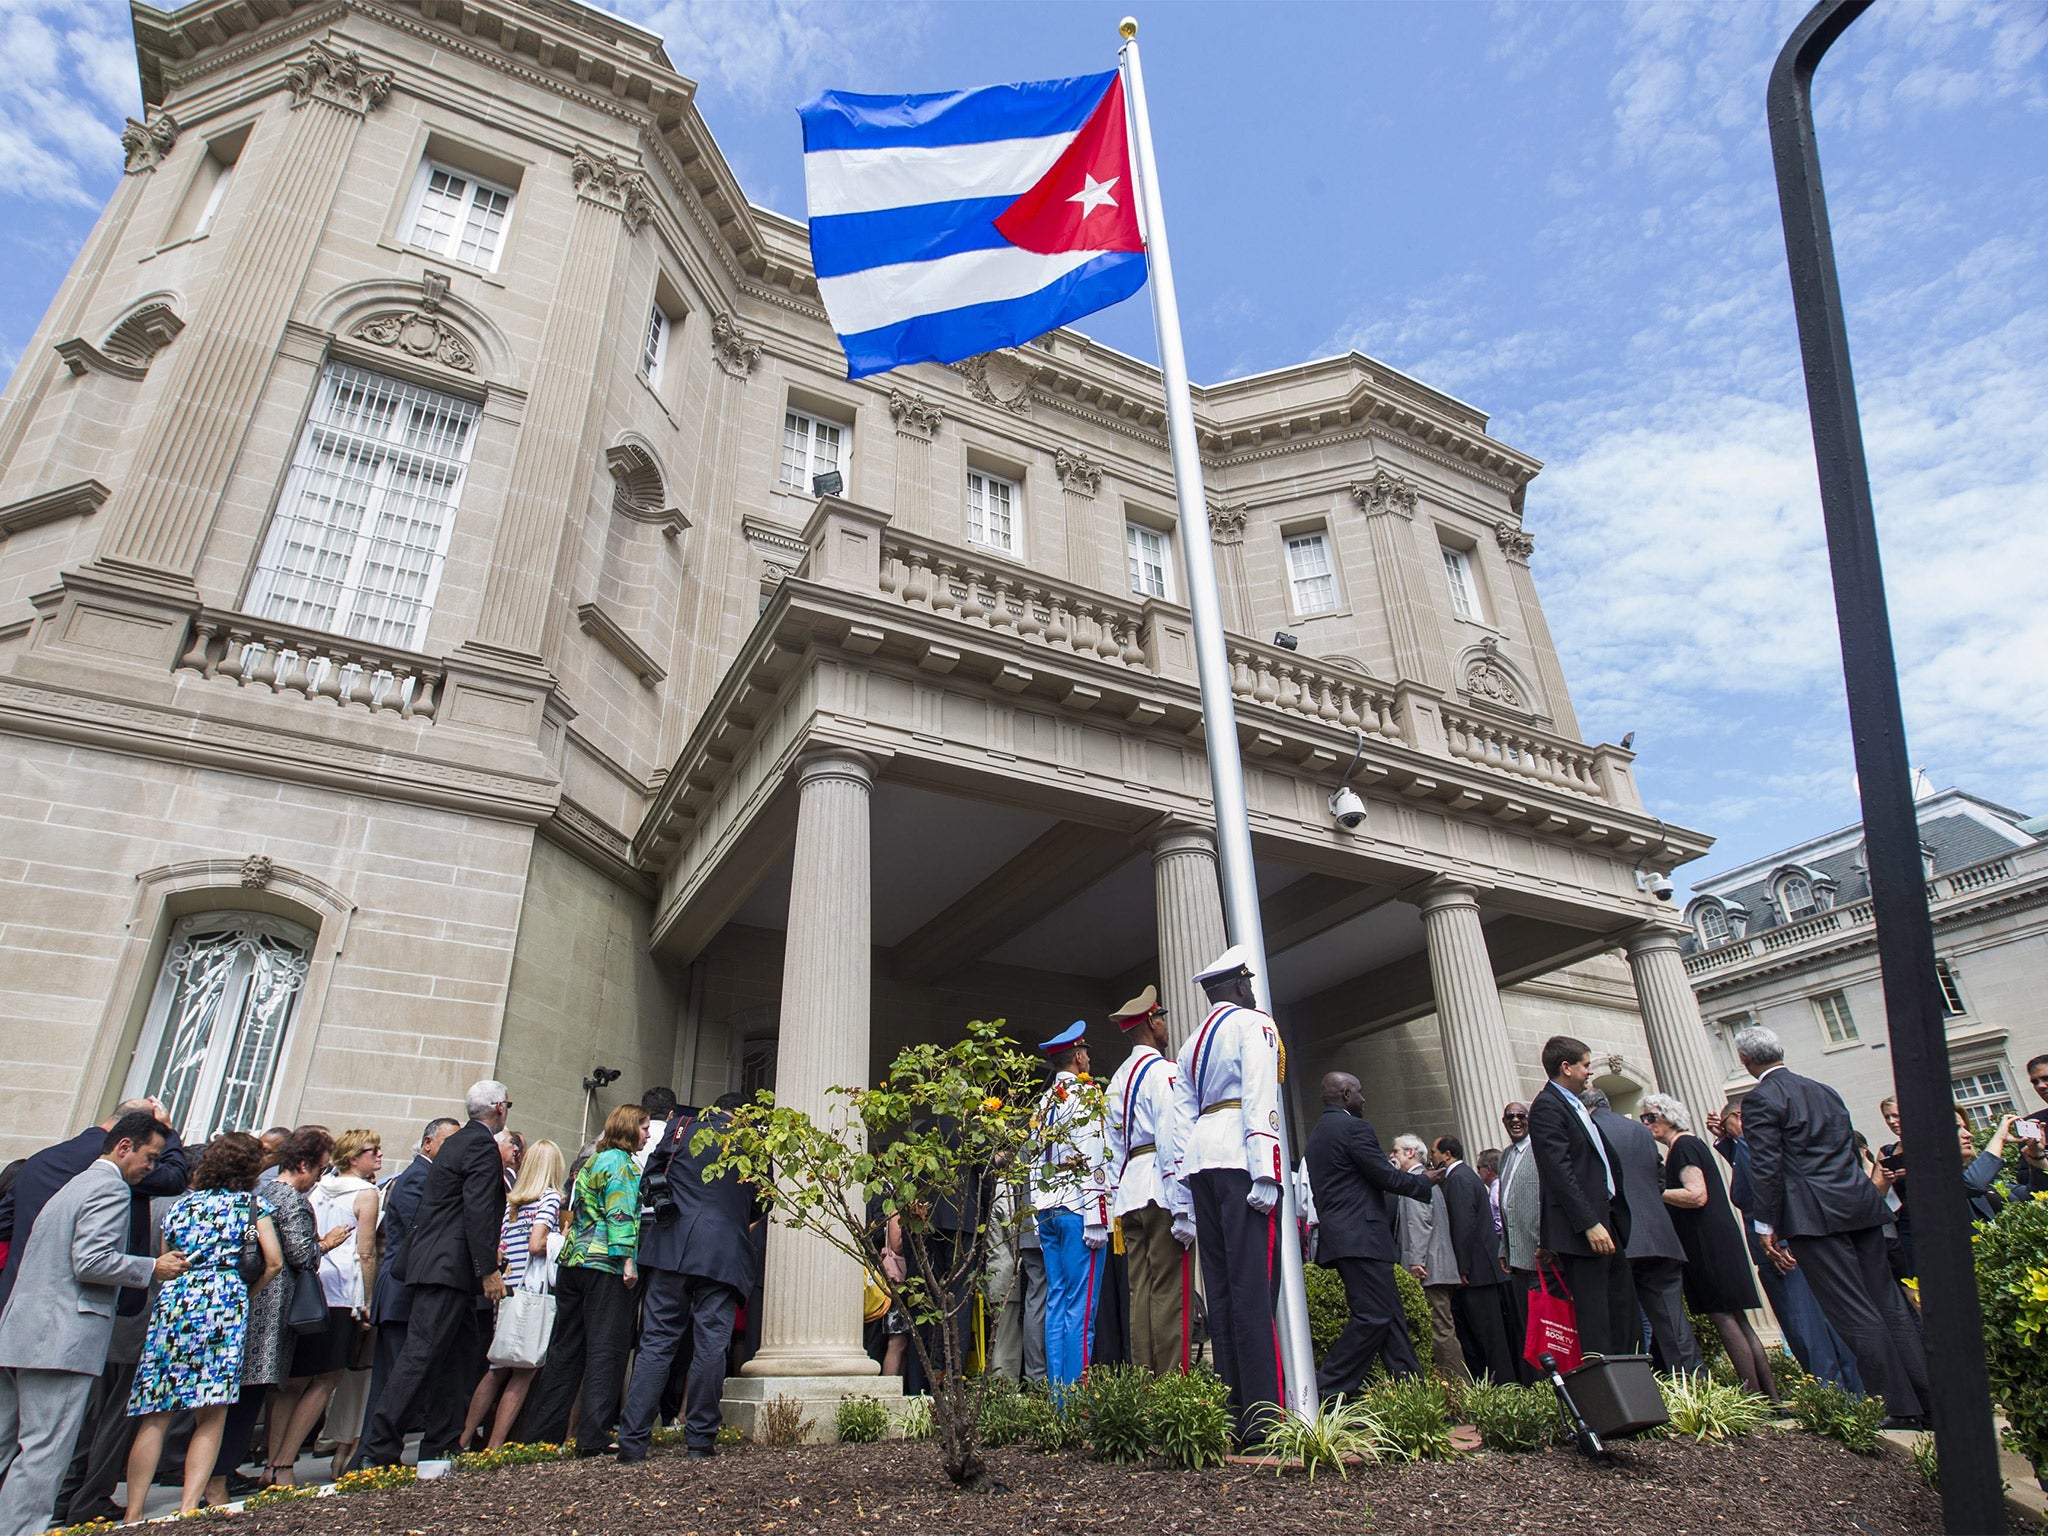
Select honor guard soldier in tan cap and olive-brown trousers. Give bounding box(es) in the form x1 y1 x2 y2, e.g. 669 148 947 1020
1104 987 1194 1376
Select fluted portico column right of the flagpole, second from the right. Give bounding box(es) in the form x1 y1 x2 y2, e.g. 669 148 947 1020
1421 877 1528 1157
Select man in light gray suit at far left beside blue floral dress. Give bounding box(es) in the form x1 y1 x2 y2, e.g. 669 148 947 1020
0 1110 186 1536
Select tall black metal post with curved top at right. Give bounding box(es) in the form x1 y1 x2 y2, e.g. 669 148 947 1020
1767 0 2005 1532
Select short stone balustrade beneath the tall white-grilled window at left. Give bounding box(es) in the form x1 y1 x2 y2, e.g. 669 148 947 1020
174 608 444 723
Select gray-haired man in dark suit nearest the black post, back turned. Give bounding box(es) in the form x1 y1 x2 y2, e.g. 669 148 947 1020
1735 1026 1927 1430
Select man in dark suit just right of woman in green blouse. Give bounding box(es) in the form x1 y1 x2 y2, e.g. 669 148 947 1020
618 1094 762 1462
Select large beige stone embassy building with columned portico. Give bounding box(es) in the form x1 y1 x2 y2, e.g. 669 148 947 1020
0 0 1720 1376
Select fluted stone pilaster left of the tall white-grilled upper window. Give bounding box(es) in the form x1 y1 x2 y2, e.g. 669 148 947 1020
100 41 391 590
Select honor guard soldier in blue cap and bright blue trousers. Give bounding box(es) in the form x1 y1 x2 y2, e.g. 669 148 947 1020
1030 1020 1110 1395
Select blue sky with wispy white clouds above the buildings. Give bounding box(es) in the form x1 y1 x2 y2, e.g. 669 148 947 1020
0 0 2048 888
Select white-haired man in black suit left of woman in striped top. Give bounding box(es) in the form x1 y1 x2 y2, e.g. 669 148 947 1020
362 1079 512 1466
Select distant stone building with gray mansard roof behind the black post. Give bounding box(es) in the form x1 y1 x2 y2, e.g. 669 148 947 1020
1686 788 2048 1145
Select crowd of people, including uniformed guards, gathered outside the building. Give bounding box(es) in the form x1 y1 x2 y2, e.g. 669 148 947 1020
0 966 2048 1536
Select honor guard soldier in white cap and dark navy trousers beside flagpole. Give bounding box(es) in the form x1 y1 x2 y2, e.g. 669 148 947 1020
1180 944 1294 1444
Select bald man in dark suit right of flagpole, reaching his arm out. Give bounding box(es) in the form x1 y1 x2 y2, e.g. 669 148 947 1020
1309 1071 1436 1399
